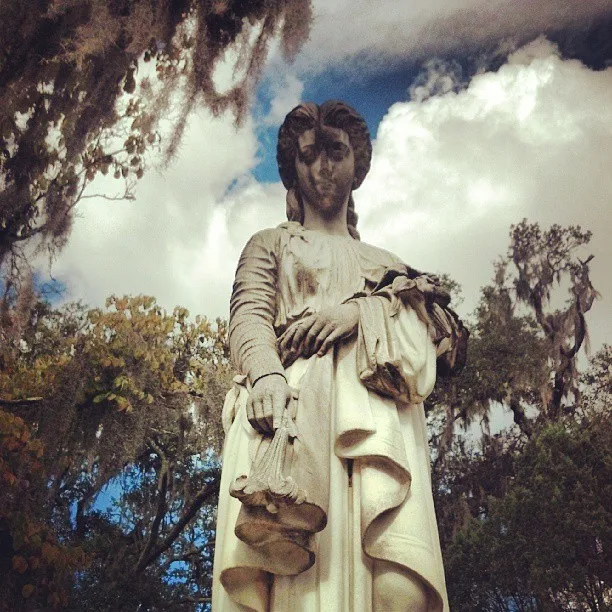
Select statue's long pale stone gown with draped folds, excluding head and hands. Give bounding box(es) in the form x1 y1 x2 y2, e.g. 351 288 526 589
213 222 462 612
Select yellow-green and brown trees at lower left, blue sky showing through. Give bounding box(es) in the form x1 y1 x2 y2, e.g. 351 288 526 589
0 296 232 610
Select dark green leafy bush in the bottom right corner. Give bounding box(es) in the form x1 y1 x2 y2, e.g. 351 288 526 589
445 414 612 611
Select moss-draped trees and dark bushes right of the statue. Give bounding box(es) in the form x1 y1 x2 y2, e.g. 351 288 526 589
429 221 612 612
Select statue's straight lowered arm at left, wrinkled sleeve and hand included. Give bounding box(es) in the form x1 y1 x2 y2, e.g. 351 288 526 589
229 230 291 433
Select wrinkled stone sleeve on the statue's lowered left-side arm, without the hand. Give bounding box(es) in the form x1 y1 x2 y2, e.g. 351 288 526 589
229 230 285 383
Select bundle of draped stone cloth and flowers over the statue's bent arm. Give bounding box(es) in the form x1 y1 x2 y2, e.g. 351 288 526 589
351 264 469 403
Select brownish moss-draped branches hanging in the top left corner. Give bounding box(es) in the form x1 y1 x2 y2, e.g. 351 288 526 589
0 0 310 282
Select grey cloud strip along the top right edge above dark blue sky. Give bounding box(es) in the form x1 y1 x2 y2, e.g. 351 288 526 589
298 0 612 72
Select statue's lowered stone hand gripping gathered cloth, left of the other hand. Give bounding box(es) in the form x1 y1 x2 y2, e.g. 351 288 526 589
246 374 293 434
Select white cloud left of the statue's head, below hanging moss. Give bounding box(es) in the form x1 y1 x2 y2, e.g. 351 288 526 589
53 112 266 316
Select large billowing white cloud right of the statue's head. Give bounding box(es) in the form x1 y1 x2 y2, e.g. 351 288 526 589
356 39 612 346
